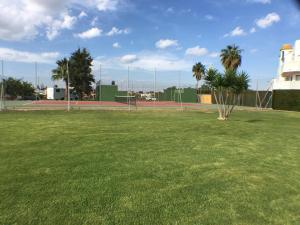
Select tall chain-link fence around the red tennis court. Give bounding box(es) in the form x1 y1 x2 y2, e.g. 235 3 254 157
0 62 272 110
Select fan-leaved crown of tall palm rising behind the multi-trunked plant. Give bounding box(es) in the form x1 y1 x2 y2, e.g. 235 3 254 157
221 45 242 71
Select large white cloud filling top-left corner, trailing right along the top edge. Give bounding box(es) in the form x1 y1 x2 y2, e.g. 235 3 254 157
0 0 126 41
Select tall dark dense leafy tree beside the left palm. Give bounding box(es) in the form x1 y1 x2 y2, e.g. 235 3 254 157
69 48 95 99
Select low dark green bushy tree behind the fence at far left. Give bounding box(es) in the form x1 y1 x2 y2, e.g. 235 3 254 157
1 77 34 98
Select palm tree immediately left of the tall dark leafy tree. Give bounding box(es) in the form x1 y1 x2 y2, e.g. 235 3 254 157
52 58 69 99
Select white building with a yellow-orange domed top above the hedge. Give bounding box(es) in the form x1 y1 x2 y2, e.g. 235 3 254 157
273 40 300 90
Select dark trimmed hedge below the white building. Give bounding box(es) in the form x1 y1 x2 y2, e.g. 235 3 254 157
272 90 300 111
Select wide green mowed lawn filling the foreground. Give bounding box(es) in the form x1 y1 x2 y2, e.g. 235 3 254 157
0 111 300 225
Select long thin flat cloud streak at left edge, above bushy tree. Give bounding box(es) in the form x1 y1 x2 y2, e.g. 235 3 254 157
0 48 59 63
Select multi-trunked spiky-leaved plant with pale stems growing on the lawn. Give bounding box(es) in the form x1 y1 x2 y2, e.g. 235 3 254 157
205 68 250 120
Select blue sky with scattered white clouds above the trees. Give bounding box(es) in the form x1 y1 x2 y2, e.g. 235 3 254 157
0 0 300 87
